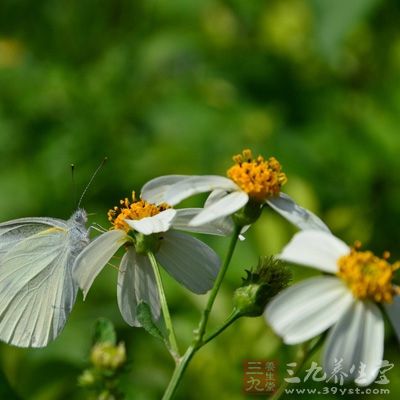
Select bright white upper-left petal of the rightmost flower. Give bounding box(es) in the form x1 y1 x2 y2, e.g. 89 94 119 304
278 230 350 273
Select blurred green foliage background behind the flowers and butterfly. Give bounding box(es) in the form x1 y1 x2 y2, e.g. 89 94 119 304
0 0 400 400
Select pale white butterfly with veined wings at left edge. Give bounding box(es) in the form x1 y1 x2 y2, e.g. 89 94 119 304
0 209 89 347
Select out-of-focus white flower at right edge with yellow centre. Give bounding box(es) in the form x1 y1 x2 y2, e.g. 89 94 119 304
265 230 400 385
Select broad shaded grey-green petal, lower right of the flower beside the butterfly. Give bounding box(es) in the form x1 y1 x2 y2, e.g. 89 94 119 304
155 231 220 294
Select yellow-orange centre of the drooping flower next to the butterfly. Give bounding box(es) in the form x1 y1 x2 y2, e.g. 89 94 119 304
107 192 171 232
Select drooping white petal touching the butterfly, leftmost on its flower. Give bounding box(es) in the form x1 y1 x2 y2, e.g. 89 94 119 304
73 229 126 298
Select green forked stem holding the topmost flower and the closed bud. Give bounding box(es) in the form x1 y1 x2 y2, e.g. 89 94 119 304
162 225 242 400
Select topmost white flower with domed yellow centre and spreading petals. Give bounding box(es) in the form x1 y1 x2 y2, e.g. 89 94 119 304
141 150 329 232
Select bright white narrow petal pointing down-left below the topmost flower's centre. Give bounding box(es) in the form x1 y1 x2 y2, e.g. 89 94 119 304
190 191 249 226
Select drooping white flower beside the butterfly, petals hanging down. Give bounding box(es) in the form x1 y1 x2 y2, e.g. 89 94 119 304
73 195 231 326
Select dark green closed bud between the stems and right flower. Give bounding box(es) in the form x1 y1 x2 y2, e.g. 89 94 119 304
233 257 292 317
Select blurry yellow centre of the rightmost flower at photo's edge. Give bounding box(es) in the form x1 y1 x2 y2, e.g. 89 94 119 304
337 243 400 303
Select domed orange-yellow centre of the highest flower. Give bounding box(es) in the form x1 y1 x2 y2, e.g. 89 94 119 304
227 150 287 202
